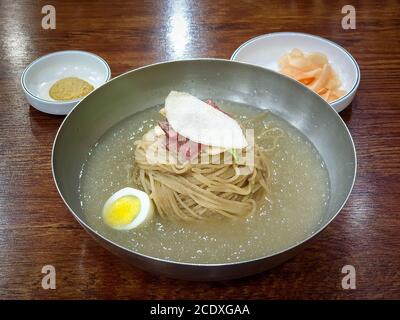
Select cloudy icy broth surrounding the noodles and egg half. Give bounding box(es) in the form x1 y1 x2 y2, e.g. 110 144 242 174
80 101 330 263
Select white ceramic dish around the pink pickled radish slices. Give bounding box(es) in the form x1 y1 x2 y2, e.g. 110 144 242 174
231 32 360 112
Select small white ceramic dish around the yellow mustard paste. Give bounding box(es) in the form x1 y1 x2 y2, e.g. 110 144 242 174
21 50 111 115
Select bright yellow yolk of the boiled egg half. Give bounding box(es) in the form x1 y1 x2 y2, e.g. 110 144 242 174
104 196 140 228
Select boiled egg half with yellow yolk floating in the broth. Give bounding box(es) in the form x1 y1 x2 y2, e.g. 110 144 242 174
103 187 154 230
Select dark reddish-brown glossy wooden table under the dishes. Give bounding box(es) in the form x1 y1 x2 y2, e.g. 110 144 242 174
0 0 400 299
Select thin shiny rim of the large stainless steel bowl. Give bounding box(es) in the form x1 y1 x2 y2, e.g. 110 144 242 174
51 58 358 268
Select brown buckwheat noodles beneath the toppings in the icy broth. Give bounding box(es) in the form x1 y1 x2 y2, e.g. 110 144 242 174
129 116 284 221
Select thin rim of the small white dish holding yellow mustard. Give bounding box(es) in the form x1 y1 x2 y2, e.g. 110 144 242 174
21 50 111 106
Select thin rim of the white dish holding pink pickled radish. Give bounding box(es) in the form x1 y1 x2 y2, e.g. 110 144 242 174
230 31 361 109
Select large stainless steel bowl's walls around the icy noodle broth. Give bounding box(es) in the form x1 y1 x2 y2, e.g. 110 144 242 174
52 59 356 280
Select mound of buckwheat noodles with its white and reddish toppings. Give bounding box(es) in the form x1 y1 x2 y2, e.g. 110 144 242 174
129 91 283 221
